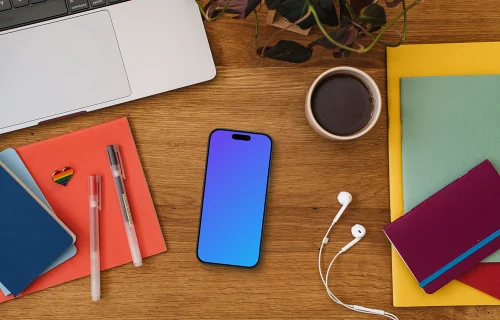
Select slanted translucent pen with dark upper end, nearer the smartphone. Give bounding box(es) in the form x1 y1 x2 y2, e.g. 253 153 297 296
106 145 142 267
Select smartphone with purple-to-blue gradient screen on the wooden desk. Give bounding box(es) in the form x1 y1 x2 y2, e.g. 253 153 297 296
197 129 272 268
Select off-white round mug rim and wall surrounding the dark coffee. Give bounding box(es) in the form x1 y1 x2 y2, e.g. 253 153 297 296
306 67 382 140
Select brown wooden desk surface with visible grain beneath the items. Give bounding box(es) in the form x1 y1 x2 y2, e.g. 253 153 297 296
0 0 500 320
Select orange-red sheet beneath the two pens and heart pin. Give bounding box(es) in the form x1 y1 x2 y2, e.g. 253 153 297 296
0 118 167 302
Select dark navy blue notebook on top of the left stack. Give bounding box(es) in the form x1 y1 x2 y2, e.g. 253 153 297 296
0 161 75 296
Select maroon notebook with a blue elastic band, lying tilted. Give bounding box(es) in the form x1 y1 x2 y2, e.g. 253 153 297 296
384 160 500 293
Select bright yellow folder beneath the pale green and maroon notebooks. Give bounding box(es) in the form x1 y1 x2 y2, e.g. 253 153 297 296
387 42 500 307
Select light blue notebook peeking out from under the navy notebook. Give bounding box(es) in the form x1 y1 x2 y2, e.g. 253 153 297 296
0 149 76 296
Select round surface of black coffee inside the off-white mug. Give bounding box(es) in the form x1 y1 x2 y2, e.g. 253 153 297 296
311 74 374 136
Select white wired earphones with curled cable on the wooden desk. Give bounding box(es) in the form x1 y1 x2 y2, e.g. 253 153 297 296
318 191 398 320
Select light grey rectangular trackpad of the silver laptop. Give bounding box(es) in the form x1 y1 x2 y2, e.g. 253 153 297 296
0 11 131 128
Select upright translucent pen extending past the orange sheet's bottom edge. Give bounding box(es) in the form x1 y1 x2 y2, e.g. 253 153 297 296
89 176 102 301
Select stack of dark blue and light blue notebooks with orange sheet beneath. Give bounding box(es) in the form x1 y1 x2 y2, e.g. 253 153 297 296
0 118 166 302
